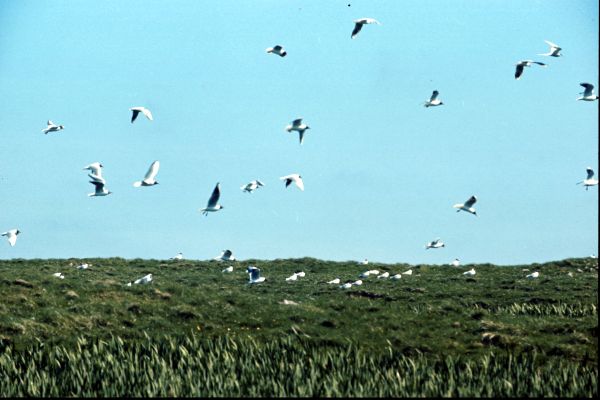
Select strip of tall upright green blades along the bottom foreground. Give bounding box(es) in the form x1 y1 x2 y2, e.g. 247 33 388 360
0 336 598 397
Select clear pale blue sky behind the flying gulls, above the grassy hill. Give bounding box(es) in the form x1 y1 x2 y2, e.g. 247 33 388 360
0 0 599 264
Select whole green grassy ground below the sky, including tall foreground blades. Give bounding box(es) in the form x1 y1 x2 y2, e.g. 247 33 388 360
0 258 598 397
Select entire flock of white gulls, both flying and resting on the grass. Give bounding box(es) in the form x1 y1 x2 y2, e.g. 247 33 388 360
2 13 599 289
